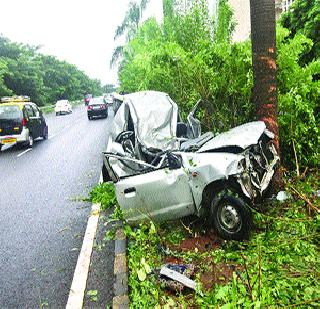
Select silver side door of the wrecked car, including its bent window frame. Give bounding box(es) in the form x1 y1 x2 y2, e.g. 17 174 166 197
104 154 195 222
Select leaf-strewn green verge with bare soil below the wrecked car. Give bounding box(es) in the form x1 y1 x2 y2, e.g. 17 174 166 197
90 172 320 308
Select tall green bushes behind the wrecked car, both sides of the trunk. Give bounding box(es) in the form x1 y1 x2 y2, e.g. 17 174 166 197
119 0 320 173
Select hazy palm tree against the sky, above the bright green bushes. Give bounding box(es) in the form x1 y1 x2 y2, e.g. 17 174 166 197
110 0 150 66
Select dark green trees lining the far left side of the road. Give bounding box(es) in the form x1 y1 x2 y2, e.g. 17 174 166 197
0 36 103 106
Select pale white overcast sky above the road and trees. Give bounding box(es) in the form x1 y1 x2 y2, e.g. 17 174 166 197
0 0 162 84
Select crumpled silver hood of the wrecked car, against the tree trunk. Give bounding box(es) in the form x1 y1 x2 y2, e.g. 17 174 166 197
197 121 273 152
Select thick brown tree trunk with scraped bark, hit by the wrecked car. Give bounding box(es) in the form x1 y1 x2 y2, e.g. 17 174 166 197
250 0 280 188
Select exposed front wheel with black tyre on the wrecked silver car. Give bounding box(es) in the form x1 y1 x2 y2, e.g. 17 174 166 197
211 195 252 240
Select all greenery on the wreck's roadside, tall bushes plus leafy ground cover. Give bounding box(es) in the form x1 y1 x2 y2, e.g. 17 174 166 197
93 0 320 308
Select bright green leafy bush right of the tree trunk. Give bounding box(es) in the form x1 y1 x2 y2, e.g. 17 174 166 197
277 27 320 168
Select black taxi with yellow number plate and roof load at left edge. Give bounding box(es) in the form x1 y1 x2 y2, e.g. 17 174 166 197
0 96 48 150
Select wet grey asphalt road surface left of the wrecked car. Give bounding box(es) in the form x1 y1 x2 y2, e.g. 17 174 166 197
0 106 112 308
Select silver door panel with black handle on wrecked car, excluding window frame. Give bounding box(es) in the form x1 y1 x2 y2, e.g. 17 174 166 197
116 169 195 222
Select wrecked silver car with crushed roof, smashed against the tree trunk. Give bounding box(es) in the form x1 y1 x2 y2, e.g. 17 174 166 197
103 91 279 240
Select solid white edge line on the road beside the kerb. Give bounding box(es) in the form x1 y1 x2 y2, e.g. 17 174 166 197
66 173 102 309
